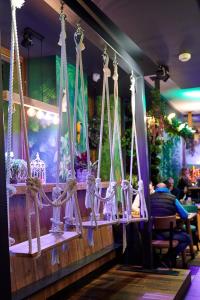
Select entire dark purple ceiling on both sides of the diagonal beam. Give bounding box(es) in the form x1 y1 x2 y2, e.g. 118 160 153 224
0 0 200 99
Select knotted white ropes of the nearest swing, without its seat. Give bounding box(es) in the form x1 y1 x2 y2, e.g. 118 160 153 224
7 0 82 258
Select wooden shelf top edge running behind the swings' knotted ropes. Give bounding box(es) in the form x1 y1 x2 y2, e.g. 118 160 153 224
13 181 109 195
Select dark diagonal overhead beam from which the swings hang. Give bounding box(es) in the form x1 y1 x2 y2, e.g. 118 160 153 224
43 0 157 76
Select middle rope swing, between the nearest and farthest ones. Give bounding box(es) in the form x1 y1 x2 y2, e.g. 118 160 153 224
74 40 118 229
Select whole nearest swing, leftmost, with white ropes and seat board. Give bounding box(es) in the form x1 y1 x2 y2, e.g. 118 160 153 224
7 0 82 262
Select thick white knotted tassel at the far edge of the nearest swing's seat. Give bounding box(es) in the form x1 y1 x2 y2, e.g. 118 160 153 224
49 187 63 233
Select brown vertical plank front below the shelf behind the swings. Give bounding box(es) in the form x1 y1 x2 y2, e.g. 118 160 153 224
10 191 114 299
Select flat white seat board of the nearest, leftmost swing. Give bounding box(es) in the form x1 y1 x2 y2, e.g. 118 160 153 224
9 231 80 257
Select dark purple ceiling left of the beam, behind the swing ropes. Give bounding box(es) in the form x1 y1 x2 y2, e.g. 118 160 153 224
0 0 130 97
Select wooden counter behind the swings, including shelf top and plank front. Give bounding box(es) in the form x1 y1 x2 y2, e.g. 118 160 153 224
10 182 116 300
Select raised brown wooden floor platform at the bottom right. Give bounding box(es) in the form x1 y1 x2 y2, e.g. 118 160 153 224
59 266 191 300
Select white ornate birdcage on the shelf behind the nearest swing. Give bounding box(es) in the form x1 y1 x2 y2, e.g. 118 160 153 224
31 152 46 183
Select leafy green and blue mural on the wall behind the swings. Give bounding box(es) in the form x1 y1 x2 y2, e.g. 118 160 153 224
28 56 88 182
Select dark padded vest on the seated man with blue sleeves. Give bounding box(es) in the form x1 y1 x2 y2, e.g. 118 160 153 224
150 192 177 217
